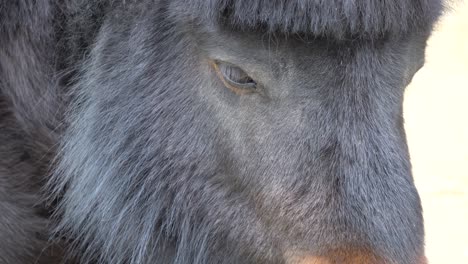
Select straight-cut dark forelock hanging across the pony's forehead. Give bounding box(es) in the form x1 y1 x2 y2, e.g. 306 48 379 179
177 0 442 38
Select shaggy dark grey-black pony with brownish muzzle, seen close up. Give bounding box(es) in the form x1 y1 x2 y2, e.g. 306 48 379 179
0 0 442 264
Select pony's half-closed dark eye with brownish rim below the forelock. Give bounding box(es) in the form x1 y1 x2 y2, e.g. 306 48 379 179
213 61 257 94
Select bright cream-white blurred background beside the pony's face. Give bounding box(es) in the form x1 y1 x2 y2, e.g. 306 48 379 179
404 0 468 264
